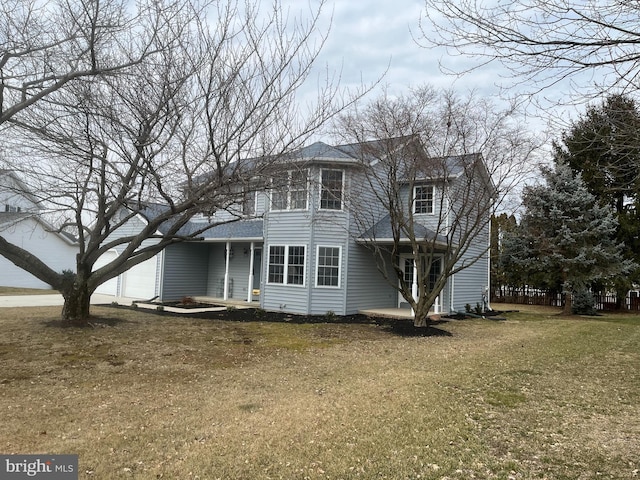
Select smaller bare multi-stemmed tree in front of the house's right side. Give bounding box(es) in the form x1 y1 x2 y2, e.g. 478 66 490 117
337 87 539 326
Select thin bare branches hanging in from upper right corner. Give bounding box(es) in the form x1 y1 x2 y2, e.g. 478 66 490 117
420 0 640 101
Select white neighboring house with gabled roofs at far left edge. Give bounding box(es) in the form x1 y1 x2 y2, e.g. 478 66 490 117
0 170 78 289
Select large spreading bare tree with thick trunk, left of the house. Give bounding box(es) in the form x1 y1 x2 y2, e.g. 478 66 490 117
0 0 362 325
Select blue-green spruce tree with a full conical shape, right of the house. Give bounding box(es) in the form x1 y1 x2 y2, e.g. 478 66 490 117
508 161 634 314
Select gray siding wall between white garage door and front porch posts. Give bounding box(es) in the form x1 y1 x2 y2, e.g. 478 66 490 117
162 242 209 301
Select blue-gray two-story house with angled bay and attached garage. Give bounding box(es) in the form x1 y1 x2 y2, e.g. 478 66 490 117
98 137 491 315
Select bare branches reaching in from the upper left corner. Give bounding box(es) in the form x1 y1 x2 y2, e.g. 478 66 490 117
0 0 161 124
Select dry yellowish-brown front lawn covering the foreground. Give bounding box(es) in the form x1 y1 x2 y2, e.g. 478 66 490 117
0 308 640 479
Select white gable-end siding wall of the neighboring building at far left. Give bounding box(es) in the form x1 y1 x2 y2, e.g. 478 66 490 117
0 218 78 289
